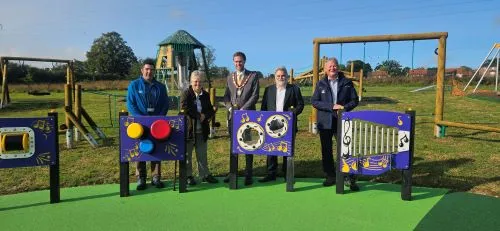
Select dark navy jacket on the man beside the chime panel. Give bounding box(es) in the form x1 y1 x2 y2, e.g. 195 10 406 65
311 72 359 129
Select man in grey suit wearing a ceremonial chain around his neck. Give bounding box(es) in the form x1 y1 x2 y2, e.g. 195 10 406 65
224 51 259 185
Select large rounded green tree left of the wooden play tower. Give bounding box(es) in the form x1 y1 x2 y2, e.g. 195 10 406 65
87 31 137 76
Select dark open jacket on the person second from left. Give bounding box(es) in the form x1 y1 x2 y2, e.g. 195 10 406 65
181 86 215 141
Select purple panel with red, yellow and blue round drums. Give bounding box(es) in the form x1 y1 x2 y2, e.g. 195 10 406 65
120 116 185 162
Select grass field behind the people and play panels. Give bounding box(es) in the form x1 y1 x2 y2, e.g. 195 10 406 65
0 86 500 197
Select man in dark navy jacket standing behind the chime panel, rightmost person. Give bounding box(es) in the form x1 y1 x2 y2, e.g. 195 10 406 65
311 58 359 191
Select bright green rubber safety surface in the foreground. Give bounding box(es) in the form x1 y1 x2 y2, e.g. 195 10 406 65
0 178 500 230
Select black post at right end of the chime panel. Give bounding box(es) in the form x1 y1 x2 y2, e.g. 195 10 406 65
401 109 416 201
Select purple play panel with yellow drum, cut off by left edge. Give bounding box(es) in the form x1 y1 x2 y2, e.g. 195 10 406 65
0 117 58 168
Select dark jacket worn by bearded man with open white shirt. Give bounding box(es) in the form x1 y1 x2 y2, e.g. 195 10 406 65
260 84 304 131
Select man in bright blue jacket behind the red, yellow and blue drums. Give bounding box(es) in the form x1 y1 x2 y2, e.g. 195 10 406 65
127 59 168 190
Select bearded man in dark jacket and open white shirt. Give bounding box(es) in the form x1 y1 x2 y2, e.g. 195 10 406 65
259 67 304 182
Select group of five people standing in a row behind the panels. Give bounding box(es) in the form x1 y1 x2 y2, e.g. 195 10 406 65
127 52 359 191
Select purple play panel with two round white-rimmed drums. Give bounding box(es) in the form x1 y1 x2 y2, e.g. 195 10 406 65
231 110 295 156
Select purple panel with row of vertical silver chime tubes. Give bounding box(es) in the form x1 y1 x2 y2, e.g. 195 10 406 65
338 111 411 175
